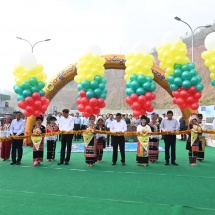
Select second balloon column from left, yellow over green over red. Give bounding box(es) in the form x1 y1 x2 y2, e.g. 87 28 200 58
74 53 107 117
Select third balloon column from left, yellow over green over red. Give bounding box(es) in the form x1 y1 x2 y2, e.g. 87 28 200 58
124 52 156 117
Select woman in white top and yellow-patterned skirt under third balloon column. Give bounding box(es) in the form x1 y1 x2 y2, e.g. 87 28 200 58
137 116 151 166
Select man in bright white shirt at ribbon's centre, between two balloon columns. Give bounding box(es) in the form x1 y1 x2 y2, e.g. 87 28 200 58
110 113 127 166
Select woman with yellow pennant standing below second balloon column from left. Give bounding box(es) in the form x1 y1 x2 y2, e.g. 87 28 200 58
83 115 97 166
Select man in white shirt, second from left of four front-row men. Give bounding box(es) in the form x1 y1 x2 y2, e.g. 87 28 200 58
58 109 75 165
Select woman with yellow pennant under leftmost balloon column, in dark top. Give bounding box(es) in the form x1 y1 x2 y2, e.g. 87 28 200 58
31 116 46 166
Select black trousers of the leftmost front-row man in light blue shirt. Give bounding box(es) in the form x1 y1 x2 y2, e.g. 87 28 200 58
11 134 24 163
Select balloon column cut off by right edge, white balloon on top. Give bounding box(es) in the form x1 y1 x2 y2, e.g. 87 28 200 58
201 32 215 86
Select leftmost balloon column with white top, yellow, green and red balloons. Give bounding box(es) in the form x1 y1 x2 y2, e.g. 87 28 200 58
13 53 50 117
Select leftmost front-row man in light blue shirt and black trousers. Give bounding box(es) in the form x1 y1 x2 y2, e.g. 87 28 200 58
10 111 25 165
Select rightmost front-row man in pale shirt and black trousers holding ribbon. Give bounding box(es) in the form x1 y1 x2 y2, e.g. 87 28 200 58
160 110 179 166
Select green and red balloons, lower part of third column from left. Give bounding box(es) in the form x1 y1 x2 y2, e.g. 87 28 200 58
126 74 156 117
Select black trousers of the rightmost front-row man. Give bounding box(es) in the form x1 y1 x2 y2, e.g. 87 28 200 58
164 135 176 162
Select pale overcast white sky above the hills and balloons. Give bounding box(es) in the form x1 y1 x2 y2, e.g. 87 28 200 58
0 0 215 89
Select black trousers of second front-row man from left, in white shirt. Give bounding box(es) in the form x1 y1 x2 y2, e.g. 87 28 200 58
60 134 73 162
